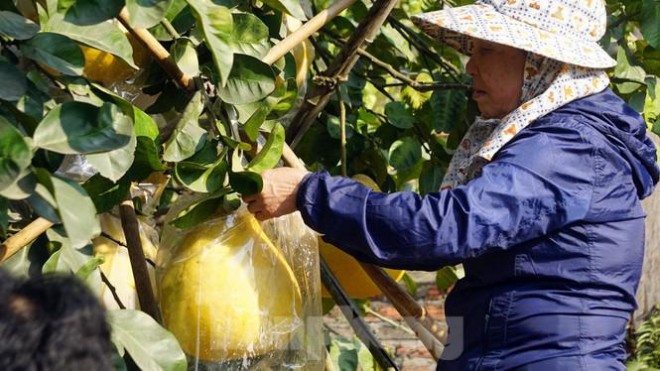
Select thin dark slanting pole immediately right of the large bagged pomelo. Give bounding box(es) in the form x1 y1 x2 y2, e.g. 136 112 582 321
320 257 398 370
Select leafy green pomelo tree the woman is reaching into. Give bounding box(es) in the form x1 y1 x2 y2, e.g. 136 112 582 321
0 0 660 369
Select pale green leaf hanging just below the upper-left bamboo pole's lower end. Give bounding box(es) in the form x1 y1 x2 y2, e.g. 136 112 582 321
163 91 206 162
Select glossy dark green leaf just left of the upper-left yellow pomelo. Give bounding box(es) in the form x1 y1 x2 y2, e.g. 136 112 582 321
21 32 85 76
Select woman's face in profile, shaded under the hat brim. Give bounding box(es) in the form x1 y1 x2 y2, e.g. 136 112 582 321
466 39 527 118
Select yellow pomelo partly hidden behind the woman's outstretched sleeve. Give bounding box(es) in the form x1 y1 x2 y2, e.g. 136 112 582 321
319 174 406 299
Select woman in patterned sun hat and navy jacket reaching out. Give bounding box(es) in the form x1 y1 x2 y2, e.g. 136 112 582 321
245 0 659 370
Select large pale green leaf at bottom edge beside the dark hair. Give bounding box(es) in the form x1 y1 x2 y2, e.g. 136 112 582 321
108 309 187 371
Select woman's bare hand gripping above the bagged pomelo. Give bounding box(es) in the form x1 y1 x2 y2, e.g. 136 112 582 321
243 167 308 220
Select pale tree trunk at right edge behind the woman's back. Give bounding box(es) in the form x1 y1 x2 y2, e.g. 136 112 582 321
634 134 660 322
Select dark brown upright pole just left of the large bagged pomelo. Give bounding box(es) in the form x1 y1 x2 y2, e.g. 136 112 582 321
119 195 161 323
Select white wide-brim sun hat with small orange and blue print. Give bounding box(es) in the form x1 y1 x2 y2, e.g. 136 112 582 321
412 0 616 69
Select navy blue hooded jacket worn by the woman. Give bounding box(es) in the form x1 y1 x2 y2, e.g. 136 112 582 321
297 89 659 370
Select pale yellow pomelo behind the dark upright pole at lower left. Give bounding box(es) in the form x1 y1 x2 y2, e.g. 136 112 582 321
92 213 157 309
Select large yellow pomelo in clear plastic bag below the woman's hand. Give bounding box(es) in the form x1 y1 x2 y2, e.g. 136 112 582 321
159 213 302 361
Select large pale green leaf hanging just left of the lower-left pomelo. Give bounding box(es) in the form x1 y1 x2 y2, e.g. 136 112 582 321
36 169 101 249
